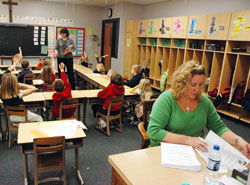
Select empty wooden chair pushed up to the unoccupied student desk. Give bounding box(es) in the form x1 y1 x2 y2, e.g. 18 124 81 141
33 136 67 185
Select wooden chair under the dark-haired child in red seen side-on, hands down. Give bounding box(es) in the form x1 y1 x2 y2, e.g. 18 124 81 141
96 95 124 136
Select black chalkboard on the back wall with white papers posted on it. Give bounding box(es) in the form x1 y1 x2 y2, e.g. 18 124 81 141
0 25 48 56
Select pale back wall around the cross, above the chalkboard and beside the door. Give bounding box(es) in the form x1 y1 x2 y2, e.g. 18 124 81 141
0 0 104 64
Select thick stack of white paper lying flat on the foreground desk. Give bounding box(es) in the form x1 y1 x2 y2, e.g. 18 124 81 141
161 143 201 171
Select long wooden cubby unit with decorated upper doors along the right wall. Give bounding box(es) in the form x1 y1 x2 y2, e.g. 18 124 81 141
124 11 250 123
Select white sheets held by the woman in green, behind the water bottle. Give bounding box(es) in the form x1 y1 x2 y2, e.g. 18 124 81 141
196 130 249 173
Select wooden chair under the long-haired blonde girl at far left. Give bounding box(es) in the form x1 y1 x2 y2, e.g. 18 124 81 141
5 105 28 148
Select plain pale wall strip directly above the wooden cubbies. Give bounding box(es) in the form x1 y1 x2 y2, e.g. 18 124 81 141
143 0 250 19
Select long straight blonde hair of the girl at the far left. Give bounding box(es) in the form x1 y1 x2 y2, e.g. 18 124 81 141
0 73 19 99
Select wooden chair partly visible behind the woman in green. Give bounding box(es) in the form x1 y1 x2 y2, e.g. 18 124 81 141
138 99 156 149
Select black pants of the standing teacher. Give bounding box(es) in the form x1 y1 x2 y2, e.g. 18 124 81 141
57 57 75 90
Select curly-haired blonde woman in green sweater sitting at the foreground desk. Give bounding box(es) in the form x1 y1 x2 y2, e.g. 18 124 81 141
147 61 250 156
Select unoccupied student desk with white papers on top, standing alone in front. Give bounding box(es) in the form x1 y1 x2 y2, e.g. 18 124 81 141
17 121 86 185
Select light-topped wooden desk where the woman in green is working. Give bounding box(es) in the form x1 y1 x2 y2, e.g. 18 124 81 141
108 146 206 185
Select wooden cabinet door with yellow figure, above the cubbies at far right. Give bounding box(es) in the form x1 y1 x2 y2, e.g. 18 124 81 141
228 10 250 41
